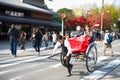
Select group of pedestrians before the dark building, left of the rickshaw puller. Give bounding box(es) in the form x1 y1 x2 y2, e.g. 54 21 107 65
8 24 57 57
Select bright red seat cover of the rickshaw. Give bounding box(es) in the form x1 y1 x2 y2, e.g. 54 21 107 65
68 35 92 53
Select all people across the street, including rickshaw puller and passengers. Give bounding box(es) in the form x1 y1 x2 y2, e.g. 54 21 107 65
8 24 120 76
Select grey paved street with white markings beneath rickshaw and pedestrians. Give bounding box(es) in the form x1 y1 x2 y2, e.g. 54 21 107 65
0 40 120 80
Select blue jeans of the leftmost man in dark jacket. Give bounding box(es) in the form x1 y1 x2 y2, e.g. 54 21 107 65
10 38 17 55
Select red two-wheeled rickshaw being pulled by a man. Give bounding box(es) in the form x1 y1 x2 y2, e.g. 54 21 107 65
60 35 97 72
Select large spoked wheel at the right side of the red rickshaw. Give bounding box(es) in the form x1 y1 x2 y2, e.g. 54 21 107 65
86 45 97 72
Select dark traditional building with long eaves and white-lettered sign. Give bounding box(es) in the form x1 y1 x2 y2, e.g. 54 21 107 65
0 0 61 39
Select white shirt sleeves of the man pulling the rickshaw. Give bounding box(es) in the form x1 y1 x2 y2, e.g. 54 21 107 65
53 39 72 56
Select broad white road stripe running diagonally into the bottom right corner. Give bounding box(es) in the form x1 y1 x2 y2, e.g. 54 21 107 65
81 58 120 80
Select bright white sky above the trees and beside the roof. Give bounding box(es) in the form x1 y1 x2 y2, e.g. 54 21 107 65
44 0 120 11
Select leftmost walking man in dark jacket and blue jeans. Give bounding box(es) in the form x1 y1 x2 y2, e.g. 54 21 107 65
8 24 19 57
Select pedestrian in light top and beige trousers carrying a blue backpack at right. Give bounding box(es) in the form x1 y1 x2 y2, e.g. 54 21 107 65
103 30 114 57
